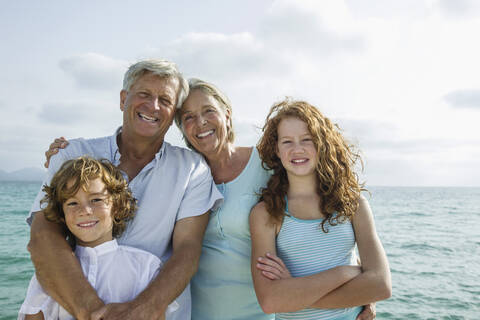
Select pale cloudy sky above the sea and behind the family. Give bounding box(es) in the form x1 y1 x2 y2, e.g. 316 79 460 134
0 0 480 186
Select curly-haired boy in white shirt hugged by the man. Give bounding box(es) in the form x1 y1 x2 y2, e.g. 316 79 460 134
18 157 178 320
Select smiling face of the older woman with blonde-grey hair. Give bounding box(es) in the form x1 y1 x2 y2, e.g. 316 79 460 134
179 89 230 155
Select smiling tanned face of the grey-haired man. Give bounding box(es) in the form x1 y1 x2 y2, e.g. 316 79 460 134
120 73 179 140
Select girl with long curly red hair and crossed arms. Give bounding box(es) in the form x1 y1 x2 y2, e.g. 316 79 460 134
250 99 391 319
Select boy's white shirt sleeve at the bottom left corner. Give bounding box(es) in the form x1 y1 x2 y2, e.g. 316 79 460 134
17 275 60 319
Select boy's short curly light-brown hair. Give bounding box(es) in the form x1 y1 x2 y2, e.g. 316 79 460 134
41 157 137 238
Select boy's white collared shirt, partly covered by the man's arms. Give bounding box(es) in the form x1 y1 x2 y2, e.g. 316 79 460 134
18 240 179 320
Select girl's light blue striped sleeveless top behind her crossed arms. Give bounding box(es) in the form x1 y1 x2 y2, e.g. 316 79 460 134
275 202 361 320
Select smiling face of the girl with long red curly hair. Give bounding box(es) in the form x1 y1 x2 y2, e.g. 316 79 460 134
277 117 317 176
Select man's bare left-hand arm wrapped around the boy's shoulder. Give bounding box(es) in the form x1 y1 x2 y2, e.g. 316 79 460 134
28 211 103 320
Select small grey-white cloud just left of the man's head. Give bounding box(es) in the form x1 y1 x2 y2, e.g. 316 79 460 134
59 53 128 90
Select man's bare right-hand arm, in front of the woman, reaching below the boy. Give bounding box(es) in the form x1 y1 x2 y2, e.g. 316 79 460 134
92 214 208 320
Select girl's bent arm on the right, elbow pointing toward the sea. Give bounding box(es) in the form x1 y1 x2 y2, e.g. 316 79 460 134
312 196 392 309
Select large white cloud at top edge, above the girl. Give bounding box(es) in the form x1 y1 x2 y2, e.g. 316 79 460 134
259 0 366 56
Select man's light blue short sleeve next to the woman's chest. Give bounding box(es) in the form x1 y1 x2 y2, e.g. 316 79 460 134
177 158 223 221
